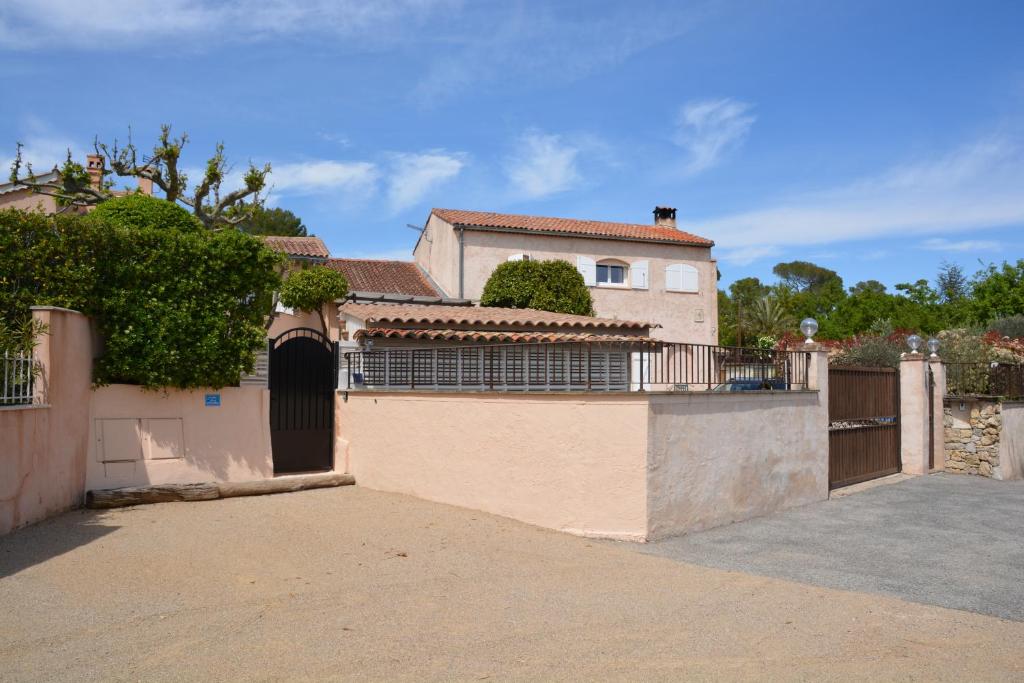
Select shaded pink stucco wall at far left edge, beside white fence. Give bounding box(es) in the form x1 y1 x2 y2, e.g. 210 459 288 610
0 307 92 535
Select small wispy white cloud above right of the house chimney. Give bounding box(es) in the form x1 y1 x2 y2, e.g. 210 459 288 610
673 98 757 175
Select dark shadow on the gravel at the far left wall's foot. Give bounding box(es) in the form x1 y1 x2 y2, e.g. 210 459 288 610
0 510 120 579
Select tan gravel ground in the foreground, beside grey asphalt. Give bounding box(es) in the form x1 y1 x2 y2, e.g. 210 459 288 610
0 486 1024 681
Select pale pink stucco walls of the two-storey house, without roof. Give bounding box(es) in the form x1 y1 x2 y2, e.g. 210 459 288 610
415 215 718 344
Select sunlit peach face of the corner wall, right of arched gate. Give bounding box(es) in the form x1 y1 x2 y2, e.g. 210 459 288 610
336 391 647 540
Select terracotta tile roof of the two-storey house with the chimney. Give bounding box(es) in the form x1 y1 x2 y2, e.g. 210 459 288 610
432 209 715 247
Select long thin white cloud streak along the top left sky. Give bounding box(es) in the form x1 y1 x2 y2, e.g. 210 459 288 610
0 0 453 50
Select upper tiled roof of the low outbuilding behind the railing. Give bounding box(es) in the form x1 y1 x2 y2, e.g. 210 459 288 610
340 303 655 330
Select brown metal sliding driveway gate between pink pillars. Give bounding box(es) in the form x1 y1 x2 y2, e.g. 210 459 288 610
828 368 900 488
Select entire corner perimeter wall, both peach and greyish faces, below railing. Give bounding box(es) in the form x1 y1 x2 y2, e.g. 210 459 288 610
336 391 828 541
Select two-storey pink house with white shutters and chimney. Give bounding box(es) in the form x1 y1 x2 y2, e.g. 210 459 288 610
414 207 718 345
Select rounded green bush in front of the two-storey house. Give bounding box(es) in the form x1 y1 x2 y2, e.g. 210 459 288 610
480 261 594 315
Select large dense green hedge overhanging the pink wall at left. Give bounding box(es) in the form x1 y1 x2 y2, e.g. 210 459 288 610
0 211 282 388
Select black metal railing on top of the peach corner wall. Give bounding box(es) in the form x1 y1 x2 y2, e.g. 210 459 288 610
342 341 809 391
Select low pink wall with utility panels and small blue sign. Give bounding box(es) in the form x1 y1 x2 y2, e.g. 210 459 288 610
86 384 273 489
